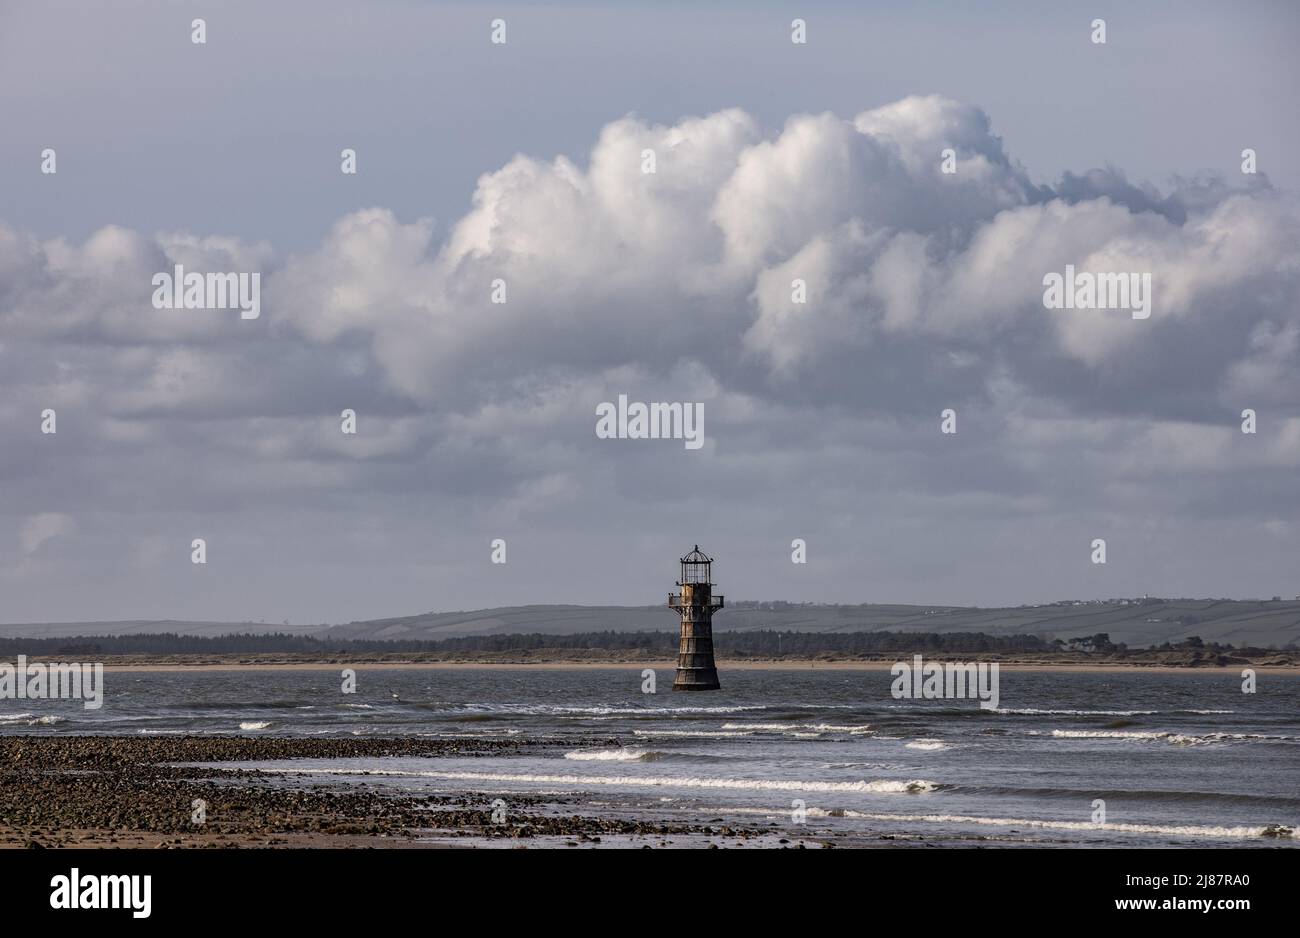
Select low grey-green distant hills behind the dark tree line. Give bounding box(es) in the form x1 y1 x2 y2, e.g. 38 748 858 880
0 599 1300 648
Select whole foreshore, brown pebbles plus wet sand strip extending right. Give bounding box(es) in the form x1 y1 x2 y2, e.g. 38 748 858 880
0 735 1294 850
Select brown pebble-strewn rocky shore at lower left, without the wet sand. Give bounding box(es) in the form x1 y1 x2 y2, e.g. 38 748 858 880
0 737 768 848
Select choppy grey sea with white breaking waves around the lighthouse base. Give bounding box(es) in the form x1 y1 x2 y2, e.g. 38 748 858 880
0 668 1300 847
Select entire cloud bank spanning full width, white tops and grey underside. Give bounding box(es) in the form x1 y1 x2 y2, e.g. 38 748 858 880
0 96 1300 613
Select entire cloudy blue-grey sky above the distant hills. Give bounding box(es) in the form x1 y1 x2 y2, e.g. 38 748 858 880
0 0 1300 627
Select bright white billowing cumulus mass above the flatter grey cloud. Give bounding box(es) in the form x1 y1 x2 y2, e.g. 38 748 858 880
258 97 1300 418
